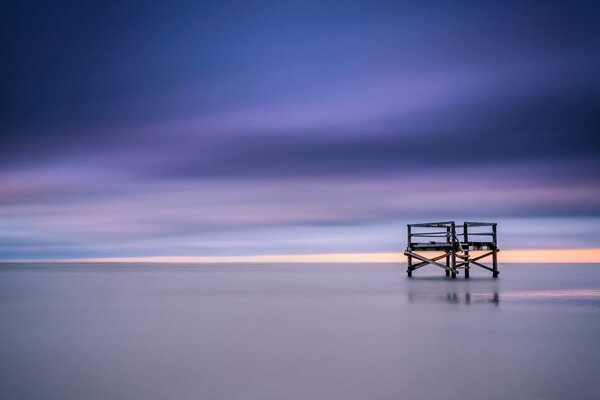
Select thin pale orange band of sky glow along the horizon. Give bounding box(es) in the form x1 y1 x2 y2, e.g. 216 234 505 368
4 248 600 263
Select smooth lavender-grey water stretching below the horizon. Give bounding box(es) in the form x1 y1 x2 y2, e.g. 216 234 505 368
0 264 600 400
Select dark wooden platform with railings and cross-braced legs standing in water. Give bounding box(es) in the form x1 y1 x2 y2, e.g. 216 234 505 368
404 221 499 278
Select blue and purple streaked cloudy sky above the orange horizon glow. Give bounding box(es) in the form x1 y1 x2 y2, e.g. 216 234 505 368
0 0 600 260
